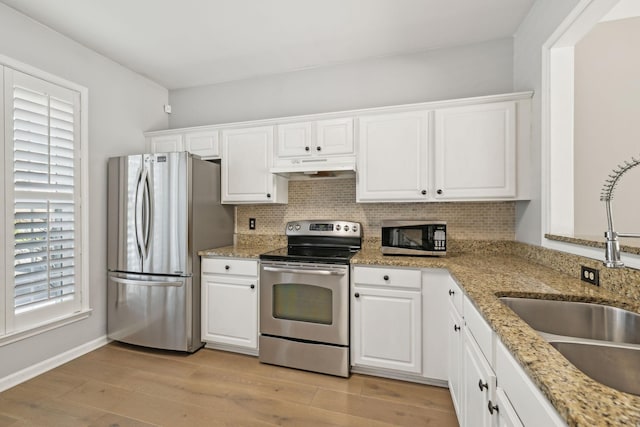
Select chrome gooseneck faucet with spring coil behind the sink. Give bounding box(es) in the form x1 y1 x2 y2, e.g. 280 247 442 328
600 157 640 268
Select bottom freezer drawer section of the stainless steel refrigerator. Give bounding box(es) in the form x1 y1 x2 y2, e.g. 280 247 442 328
107 273 202 352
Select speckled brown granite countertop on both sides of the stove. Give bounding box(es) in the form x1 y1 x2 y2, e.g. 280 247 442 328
200 242 640 426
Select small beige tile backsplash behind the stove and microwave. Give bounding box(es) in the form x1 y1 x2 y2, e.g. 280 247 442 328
236 178 515 240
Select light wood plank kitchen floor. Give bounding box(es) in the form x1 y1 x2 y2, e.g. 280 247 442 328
0 343 457 427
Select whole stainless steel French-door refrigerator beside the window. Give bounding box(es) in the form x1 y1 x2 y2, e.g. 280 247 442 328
107 153 233 352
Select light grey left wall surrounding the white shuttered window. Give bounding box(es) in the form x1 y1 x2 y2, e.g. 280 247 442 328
0 4 168 379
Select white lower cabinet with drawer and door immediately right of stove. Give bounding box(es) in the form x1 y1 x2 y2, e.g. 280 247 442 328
351 267 422 374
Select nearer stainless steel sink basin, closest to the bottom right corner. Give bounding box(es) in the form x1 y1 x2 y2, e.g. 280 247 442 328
550 341 640 395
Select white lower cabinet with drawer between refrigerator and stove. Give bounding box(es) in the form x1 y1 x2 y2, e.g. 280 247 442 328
201 258 258 354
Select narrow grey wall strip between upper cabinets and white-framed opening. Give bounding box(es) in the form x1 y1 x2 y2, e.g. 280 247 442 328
513 0 578 245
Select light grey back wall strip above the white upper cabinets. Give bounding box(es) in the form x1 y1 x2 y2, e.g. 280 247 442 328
169 38 513 128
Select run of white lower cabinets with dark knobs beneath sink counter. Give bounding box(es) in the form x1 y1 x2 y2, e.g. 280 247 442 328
449 287 566 427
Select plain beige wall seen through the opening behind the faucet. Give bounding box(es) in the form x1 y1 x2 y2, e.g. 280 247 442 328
574 18 640 237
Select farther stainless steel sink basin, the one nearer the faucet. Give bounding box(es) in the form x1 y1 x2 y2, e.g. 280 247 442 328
500 297 640 346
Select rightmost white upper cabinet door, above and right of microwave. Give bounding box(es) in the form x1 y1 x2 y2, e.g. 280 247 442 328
434 102 516 200
